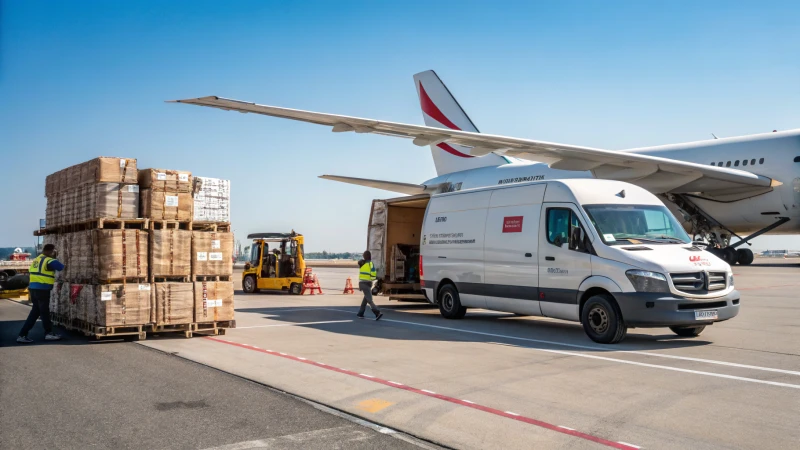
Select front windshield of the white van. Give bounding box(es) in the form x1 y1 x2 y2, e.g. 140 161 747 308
584 205 691 245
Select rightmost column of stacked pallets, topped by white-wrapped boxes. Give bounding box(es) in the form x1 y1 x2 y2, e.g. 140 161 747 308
192 177 235 333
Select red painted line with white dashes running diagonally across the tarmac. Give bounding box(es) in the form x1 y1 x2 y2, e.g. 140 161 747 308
206 337 639 450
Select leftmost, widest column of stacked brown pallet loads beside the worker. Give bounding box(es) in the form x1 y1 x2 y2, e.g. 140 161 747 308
43 157 151 338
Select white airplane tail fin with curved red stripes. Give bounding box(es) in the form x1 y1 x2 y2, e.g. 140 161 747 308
414 70 508 175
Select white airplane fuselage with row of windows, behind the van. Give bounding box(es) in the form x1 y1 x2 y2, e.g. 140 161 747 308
423 130 800 234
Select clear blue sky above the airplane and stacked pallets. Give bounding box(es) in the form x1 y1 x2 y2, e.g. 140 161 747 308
0 0 800 251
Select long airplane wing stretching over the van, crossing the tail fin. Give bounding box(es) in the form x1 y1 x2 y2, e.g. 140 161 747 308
170 96 782 196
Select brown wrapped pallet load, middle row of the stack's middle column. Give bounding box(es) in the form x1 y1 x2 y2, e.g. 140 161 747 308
150 229 192 277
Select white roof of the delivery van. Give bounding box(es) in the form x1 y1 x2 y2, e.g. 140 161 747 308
433 178 663 205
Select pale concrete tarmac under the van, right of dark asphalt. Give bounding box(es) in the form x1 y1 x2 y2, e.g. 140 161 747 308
134 260 800 449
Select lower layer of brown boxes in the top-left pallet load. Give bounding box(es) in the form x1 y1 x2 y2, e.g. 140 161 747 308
46 183 139 227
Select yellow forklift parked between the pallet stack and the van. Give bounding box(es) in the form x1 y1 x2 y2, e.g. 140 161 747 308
242 230 306 295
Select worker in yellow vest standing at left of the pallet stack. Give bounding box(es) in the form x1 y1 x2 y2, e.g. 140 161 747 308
17 244 64 344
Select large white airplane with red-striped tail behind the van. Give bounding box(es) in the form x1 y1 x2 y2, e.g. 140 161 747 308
169 70 800 265
